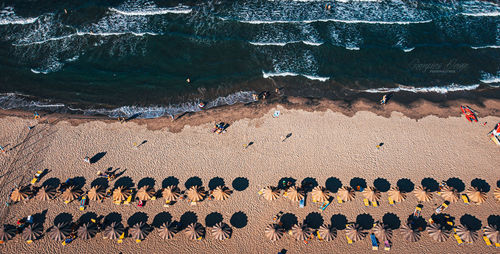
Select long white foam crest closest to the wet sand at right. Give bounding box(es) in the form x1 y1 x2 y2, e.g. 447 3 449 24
361 84 479 94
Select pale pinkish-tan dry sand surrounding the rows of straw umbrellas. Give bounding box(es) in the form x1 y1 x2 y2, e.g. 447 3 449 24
0 106 500 253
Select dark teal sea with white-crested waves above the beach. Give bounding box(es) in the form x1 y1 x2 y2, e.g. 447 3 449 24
0 0 500 117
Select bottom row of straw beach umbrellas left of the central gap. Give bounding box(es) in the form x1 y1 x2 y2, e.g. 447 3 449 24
0 219 232 243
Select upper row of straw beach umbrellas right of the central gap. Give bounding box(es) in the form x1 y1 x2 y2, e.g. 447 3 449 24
259 186 500 204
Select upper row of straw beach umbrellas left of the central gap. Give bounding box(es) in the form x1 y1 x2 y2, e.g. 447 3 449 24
10 185 233 202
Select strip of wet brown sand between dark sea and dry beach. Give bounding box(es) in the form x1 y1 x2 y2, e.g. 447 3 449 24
0 92 500 133
